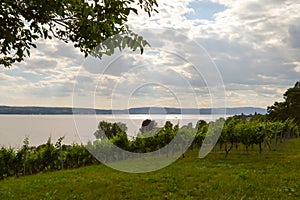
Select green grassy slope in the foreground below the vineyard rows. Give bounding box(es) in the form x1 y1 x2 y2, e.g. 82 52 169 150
0 139 300 199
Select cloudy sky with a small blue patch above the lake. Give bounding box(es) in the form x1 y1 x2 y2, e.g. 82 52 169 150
0 0 300 109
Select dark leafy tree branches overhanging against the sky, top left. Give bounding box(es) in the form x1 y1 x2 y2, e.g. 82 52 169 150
0 0 158 67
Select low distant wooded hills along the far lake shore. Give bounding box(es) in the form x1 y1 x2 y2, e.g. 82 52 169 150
0 106 267 115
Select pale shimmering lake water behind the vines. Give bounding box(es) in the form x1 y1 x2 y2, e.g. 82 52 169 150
0 115 224 148
